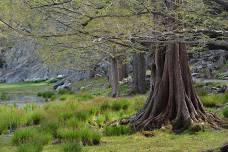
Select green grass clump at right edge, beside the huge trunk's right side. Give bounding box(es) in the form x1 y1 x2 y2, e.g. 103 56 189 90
200 94 228 107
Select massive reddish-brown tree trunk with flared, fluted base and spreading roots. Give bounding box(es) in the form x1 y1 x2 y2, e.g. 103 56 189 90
122 43 221 131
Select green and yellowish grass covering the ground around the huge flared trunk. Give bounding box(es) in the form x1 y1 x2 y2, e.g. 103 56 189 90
0 78 228 152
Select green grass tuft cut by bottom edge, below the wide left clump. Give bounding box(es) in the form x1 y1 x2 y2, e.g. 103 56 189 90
17 143 43 152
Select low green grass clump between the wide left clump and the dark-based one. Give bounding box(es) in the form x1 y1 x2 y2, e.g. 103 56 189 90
57 128 80 142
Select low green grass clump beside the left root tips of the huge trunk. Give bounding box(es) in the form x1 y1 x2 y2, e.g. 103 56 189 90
104 125 132 136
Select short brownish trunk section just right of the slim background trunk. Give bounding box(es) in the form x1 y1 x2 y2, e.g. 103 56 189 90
117 57 127 81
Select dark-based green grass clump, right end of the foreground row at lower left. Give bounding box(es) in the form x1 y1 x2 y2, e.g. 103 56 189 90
80 128 101 146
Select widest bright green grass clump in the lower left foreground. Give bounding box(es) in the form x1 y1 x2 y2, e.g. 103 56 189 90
12 128 52 145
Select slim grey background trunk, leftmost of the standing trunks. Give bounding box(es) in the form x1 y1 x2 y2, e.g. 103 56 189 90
109 58 118 97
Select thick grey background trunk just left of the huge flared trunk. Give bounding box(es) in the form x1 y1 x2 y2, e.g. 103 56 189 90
133 53 146 94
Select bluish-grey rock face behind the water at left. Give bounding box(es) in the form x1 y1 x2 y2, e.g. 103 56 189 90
0 39 89 83
